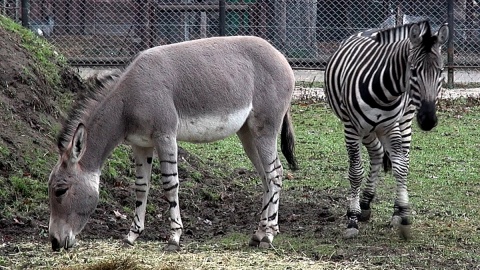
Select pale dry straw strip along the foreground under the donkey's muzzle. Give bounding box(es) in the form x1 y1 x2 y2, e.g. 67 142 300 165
2 240 363 270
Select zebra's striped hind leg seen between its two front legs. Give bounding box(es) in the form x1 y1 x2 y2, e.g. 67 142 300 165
358 133 383 221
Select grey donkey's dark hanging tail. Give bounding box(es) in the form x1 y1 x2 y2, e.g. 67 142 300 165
280 108 298 170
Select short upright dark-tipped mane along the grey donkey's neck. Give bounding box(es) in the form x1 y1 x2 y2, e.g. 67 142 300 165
57 72 120 153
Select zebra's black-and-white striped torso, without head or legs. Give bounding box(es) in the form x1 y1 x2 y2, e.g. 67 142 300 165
325 35 408 132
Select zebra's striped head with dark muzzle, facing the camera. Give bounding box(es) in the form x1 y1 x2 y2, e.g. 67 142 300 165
409 21 448 131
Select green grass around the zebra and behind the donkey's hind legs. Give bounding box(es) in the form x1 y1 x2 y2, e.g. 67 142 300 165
175 99 480 268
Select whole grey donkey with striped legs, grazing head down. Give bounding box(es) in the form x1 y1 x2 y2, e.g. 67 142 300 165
48 36 298 251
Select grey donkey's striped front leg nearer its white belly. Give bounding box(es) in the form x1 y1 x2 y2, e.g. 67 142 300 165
157 135 183 251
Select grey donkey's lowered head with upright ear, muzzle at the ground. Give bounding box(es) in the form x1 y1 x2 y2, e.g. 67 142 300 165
48 124 100 251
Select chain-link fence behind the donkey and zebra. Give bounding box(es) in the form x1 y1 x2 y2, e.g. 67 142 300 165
1 0 480 86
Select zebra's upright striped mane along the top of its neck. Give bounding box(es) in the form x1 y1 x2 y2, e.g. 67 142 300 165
362 20 432 44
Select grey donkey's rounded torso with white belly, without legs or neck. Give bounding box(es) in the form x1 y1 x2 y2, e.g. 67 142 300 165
117 36 294 142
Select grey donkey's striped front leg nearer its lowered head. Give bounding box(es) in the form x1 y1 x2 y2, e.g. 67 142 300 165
124 146 153 245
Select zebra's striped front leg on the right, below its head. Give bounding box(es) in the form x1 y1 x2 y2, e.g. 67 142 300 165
382 127 411 239
